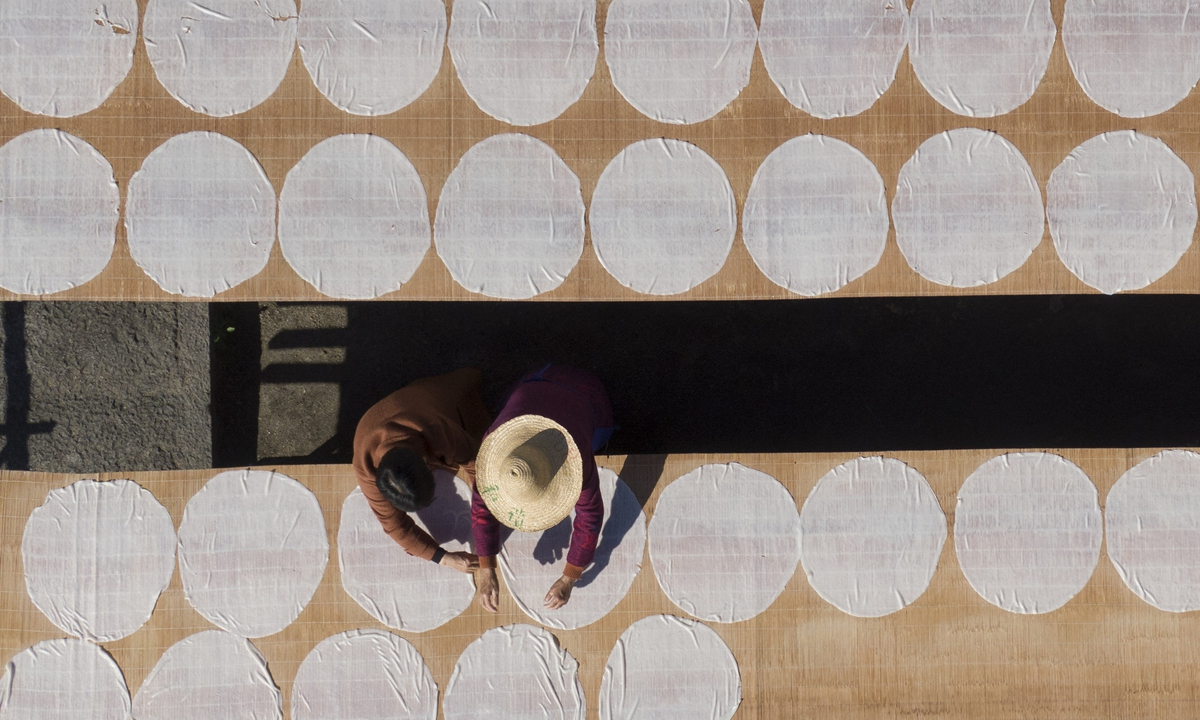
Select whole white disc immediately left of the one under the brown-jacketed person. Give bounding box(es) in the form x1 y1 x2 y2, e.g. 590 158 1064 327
179 470 329 637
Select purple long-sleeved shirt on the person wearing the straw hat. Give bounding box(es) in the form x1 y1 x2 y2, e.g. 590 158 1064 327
470 365 612 578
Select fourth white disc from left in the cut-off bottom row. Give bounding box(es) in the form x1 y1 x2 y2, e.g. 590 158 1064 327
442 624 586 720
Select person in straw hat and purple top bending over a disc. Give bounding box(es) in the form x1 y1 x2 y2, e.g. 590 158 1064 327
470 365 613 612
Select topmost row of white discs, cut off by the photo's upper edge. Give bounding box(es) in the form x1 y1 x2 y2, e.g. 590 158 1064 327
0 0 1200 125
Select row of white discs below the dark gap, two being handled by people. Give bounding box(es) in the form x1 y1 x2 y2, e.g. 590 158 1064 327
22 450 1200 657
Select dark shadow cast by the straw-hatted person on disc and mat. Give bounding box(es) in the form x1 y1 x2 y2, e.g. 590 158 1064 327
533 455 666 588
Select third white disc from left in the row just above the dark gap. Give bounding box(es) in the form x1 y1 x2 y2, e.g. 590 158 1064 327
280 134 432 300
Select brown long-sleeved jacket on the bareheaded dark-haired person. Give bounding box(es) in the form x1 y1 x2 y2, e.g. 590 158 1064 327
354 368 492 560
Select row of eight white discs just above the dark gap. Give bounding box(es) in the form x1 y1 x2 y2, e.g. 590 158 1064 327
0 128 1196 300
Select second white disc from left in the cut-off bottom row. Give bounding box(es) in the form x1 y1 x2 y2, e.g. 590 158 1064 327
133 630 283 720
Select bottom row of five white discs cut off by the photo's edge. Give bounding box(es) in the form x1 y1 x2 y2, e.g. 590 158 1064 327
0 616 742 720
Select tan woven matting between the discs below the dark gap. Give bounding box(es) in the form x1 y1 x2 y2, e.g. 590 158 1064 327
0 450 1200 720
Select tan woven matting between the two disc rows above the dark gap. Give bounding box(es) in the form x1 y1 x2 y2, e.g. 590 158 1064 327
0 0 1200 300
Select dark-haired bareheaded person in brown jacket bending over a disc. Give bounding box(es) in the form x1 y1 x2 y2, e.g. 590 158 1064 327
354 368 492 572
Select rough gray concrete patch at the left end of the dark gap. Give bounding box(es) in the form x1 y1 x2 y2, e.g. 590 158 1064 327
0 302 212 473
